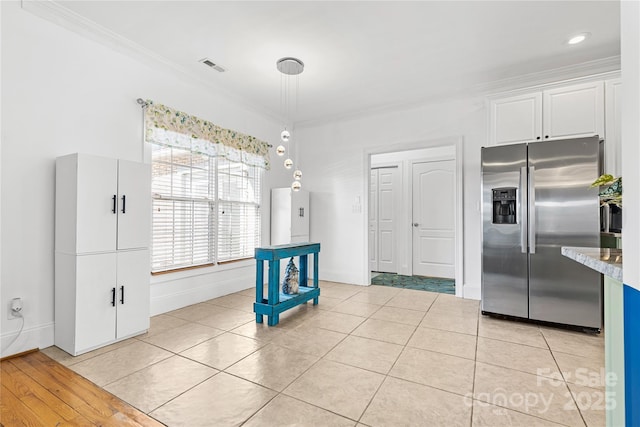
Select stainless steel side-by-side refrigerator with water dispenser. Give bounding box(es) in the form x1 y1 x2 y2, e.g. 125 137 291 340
482 136 602 330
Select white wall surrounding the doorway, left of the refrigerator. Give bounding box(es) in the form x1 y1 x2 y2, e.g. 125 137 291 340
298 98 487 297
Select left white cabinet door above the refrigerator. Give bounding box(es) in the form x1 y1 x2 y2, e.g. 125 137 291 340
490 92 542 145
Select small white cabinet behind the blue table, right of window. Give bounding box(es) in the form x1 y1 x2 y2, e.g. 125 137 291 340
271 188 309 245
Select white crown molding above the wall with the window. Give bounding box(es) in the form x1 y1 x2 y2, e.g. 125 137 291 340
21 0 282 127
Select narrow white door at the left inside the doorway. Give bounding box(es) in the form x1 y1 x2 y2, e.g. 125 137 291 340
378 167 399 273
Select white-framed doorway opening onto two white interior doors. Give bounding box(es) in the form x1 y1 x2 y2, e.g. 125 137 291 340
365 138 464 296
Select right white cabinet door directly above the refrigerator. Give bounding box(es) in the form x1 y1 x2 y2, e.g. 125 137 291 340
542 82 604 139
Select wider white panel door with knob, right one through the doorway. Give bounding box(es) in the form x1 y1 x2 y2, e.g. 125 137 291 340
412 160 457 279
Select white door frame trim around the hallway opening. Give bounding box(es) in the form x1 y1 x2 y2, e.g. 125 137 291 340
362 136 464 297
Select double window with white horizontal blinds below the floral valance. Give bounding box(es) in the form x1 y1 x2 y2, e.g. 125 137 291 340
151 143 262 272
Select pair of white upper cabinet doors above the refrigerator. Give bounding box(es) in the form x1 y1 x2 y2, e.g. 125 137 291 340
489 81 605 145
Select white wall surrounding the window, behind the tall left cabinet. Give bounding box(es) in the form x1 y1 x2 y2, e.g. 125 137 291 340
0 1 289 355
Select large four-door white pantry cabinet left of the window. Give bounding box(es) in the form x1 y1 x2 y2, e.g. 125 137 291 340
55 154 151 356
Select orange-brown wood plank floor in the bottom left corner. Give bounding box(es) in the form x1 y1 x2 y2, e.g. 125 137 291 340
0 351 164 427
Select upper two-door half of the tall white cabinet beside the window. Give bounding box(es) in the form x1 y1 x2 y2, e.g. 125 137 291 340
56 154 151 254
